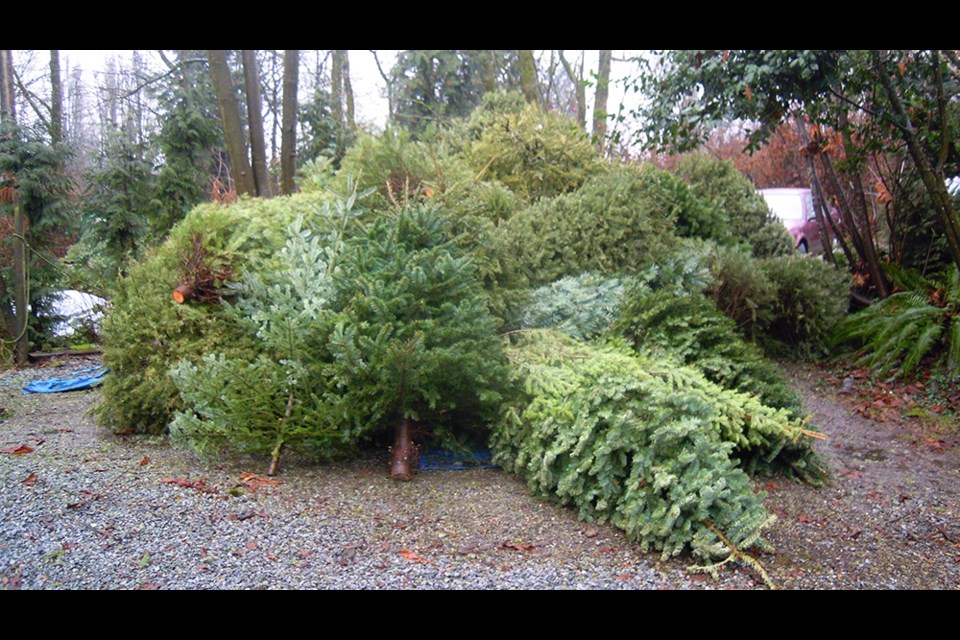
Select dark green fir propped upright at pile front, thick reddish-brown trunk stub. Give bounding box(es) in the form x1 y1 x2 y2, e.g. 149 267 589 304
330 207 504 479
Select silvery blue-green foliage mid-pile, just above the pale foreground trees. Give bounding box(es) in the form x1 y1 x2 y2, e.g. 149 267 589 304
519 273 627 340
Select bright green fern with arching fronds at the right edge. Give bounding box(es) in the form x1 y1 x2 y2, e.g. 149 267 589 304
833 267 960 378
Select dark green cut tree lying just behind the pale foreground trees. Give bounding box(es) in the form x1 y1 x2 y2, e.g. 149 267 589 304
611 289 809 422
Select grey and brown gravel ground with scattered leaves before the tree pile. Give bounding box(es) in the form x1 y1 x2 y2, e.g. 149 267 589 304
0 358 960 589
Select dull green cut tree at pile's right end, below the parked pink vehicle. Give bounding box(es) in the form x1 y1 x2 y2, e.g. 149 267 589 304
759 256 850 356
